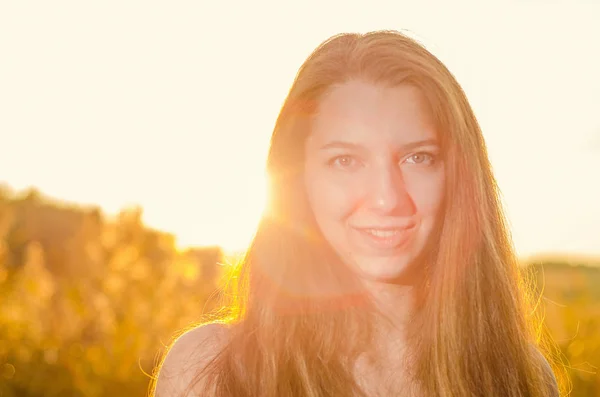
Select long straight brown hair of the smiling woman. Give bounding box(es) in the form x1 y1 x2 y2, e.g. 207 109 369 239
193 31 564 397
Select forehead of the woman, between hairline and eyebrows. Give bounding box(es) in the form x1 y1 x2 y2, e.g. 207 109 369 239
309 80 436 147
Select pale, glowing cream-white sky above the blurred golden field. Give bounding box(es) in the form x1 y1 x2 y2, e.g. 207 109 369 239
0 0 600 255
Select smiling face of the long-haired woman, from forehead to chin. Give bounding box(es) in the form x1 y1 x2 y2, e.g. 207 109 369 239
304 80 444 282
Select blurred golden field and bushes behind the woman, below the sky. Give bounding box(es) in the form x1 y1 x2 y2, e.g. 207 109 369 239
0 186 600 397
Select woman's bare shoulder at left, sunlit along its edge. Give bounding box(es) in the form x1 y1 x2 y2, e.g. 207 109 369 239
153 324 229 397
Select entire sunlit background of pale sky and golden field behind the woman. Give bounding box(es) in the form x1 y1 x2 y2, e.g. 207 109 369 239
0 0 600 397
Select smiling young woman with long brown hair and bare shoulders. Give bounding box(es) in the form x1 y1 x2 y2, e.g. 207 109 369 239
155 31 558 397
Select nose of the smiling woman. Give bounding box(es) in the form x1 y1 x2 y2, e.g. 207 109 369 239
369 166 414 216
